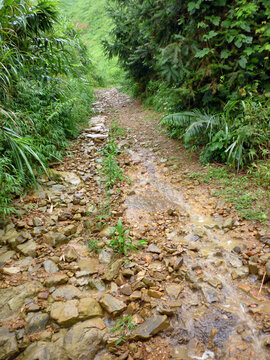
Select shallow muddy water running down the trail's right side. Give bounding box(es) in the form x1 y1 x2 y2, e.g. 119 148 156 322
125 148 270 360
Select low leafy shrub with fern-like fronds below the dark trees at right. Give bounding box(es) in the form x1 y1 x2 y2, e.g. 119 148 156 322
161 101 270 171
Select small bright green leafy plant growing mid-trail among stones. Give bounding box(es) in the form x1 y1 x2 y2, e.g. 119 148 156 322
109 219 147 255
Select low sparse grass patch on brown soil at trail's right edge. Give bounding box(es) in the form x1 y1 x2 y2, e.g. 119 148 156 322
189 164 270 222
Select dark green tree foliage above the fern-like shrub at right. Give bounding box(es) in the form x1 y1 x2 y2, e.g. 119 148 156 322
106 0 270 108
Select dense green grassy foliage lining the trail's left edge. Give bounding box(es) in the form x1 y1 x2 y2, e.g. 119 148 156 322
0 0 92 214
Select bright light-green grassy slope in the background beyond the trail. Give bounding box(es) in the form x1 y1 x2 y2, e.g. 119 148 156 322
62 0 124 87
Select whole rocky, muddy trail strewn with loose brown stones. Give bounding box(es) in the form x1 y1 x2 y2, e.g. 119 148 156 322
0 89 270 360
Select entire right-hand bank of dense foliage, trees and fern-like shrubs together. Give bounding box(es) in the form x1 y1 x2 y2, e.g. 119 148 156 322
104 0 270 168
